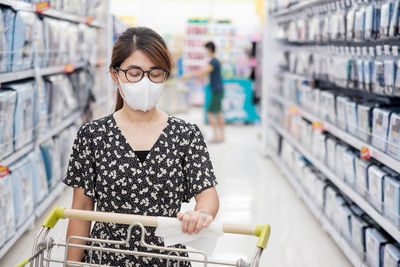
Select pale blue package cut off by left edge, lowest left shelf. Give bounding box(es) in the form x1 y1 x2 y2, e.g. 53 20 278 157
0 175 15 248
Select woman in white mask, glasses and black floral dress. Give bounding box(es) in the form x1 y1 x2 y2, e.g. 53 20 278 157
64 27 219 266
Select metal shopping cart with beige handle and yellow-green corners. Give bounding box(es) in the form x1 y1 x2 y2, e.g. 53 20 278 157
16 206 270 267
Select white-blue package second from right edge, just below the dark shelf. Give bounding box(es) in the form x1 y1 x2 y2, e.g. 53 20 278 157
372 108 390 151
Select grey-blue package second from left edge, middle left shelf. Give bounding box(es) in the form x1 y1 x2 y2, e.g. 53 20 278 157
9 82 34 150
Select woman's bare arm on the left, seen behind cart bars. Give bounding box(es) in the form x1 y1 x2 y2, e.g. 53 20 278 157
67 188 94 262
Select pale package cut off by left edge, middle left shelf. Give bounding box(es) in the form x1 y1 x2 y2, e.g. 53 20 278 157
0 89 17 159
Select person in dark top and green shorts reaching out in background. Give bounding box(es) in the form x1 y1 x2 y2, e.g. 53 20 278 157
182 42 225 143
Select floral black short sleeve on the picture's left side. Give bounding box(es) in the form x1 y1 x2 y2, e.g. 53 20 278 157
64 124 95 198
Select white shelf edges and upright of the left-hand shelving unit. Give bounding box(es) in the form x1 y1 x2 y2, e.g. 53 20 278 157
0 0 113 259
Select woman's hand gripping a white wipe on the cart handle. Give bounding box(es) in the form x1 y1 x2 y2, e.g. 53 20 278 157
176 210 214 235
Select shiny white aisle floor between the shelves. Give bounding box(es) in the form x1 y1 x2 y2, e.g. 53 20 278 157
0 109 351 267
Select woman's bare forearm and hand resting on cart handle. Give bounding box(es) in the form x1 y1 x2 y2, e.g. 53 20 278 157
177 187 219 234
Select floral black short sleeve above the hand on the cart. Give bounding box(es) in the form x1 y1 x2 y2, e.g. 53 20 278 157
183 125 218 202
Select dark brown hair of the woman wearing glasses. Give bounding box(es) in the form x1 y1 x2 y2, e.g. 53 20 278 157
110 27 171 111
